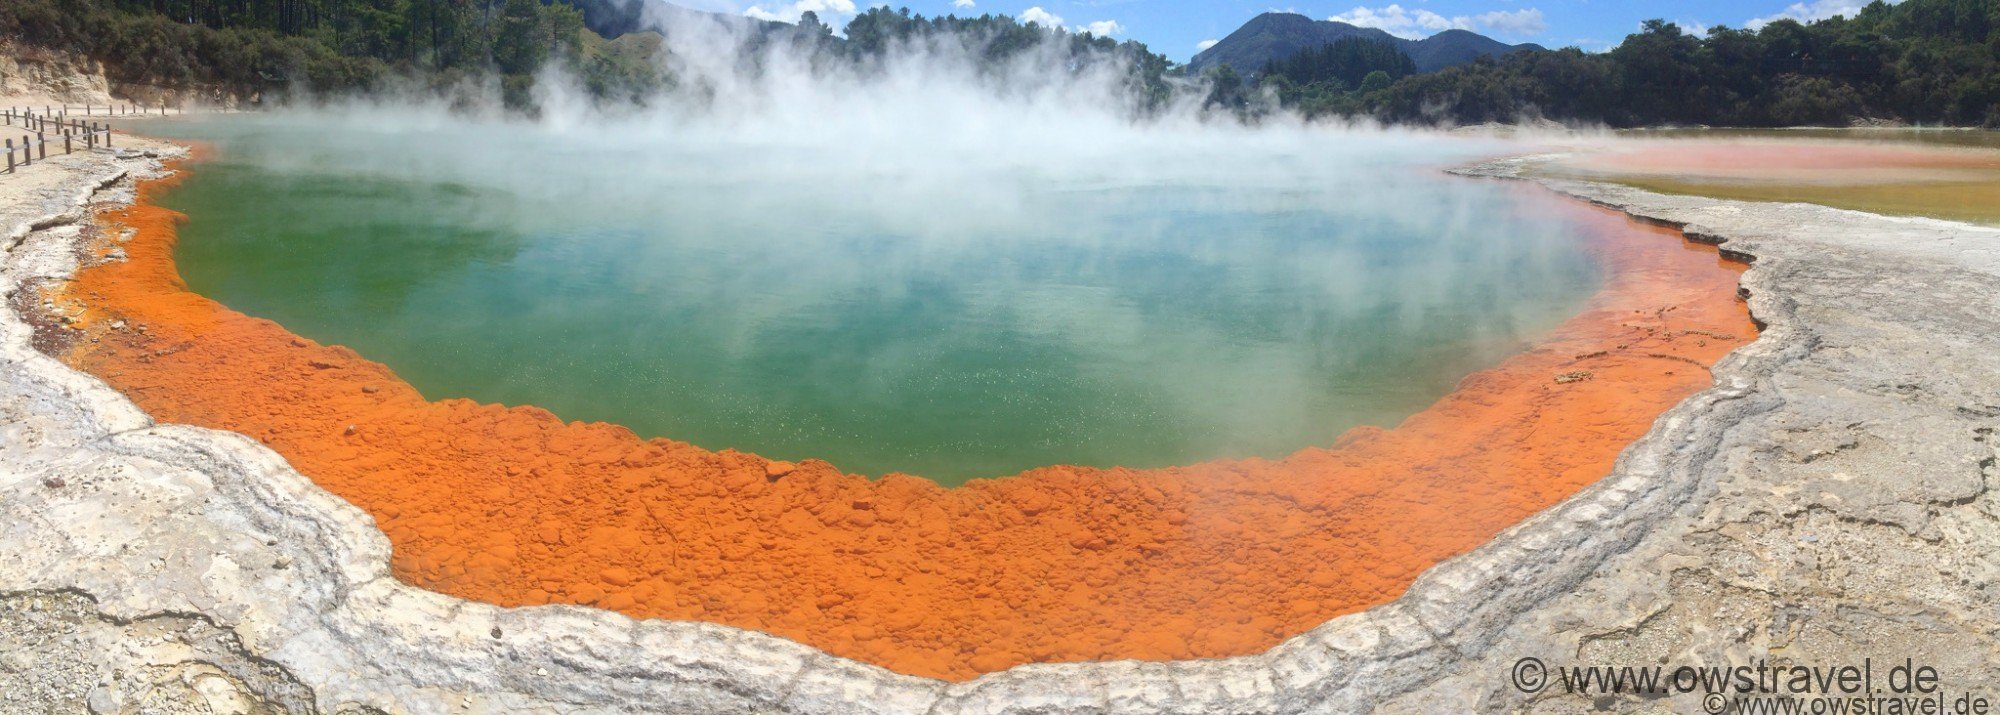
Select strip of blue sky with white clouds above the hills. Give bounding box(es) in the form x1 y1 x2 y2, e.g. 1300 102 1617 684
670 0 1900 62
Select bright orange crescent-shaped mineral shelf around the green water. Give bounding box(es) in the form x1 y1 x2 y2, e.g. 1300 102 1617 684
52 149 1756 679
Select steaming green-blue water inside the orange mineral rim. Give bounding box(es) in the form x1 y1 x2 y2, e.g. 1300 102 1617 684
144 116 1600 483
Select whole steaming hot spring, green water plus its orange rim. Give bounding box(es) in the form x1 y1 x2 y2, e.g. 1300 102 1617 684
66 114 1756 679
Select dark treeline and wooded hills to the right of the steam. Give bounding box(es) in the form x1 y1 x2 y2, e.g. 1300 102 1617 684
1258 0 2000 128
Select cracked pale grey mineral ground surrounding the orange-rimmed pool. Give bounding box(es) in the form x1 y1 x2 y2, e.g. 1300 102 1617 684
0 140 2000 713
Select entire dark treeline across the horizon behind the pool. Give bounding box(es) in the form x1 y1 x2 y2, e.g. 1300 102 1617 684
11 0 2000 126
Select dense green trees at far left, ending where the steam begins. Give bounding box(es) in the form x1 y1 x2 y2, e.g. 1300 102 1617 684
0 0 624 100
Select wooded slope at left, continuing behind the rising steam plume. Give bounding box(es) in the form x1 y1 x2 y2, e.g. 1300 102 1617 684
0 0 1172 108
